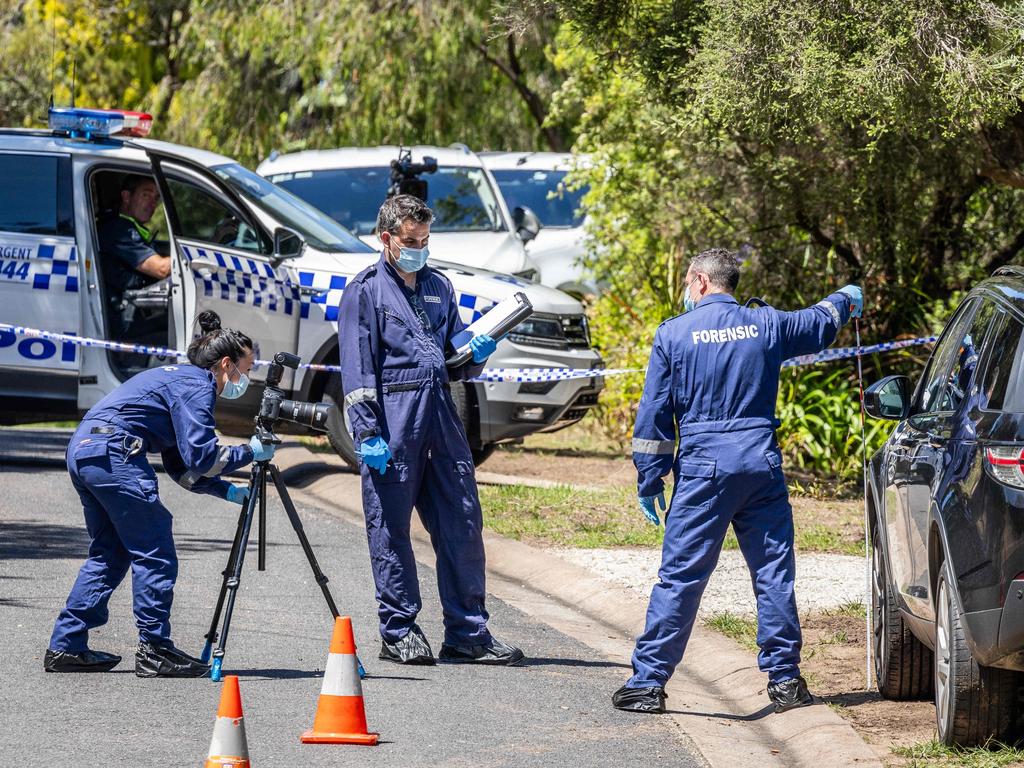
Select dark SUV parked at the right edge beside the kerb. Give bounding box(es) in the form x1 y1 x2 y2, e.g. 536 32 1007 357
865 267 1024 744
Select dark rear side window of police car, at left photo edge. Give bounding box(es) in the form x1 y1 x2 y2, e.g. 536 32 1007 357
0 154 75 236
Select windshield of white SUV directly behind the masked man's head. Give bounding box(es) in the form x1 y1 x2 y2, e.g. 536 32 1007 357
269 166 505 234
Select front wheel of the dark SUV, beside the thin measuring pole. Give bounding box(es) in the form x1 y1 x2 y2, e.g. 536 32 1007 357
871 526 932 700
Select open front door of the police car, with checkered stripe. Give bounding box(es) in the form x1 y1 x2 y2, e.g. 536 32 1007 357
146 147 300 387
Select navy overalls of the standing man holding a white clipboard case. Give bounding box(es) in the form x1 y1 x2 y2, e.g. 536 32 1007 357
338 255 490 644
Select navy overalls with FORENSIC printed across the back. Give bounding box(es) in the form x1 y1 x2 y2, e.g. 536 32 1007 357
627 293 851 688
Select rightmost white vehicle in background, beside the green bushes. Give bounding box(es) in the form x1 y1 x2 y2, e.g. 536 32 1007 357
480 152 598 296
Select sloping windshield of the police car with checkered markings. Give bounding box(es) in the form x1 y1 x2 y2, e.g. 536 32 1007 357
211 163 374 253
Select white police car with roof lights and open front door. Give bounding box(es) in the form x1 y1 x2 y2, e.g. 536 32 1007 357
0 109 601 461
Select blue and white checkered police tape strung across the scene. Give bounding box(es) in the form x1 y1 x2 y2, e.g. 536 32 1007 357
0 323 936 383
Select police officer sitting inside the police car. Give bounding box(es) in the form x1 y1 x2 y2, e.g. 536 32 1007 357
96 173 171 341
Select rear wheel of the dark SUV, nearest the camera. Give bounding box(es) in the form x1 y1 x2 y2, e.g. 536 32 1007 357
935 562 1024 746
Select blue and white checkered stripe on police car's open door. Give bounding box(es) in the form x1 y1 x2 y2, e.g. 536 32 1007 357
181 245 299 314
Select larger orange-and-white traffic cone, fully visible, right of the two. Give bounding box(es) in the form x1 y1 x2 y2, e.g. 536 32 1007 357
301 616 379 745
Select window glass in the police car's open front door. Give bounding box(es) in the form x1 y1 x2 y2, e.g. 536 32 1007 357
167 176 269 254
